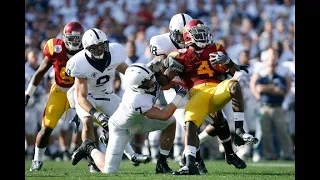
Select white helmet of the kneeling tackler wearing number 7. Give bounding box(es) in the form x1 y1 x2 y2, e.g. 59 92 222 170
124 63 157 93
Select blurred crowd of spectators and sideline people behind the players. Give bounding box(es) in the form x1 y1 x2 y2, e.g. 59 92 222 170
25 0 295 162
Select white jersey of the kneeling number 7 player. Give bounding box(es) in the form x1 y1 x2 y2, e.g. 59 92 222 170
109 88 160 129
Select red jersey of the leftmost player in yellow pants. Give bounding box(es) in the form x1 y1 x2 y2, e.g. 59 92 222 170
43 38 74 88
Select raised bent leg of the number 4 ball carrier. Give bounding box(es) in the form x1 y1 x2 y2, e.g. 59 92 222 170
210 79 258 146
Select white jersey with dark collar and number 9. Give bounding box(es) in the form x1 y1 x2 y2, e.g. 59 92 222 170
66 43 127 93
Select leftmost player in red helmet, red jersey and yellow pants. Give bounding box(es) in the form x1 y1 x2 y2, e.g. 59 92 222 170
25 22 84 171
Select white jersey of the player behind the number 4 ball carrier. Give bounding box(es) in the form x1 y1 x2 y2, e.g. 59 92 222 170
150 33 180 56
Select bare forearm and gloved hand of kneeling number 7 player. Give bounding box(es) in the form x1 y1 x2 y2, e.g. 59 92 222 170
143 86 188 121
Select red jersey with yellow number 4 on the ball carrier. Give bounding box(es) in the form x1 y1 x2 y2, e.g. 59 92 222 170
168 43 228 90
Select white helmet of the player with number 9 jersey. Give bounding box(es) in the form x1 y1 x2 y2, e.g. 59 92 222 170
82 28 109 60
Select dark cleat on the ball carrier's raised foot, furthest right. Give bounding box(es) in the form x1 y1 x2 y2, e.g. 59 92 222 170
234 128 259 146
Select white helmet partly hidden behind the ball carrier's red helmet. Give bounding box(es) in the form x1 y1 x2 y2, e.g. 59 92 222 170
169 13 192 48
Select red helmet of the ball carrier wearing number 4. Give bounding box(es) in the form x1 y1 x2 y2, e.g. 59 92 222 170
183 19 211 48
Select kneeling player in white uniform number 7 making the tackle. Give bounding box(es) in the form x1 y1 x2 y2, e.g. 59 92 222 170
72 63 187 174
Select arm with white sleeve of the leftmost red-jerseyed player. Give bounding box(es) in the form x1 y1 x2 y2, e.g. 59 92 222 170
25 56 52 105
